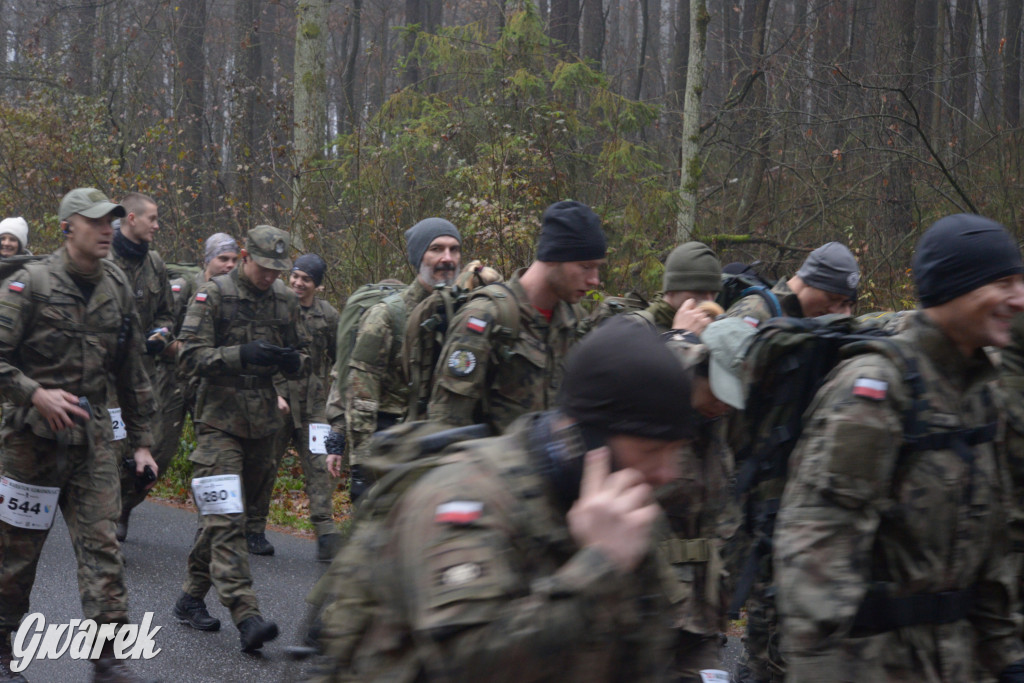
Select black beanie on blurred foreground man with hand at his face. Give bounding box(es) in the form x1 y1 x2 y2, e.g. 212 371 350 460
560 316 695 441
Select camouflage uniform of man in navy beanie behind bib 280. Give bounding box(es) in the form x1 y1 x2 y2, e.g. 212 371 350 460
246 299 338 537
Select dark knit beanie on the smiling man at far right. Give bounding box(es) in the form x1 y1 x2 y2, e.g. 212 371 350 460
910 213 1024 308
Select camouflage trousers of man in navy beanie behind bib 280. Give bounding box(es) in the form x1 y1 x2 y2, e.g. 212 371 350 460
246 417 338 538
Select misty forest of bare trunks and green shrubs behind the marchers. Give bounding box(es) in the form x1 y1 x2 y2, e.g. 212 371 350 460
0 0 1024 310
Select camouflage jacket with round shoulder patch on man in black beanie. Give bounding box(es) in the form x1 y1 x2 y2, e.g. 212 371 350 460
427 270 582 431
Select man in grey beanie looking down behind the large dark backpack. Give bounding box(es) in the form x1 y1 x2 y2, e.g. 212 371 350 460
726 242 860 328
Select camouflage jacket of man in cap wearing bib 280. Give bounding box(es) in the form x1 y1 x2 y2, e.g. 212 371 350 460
178 268 310 438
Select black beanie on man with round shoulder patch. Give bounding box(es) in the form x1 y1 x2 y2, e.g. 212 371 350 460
537 202 608 263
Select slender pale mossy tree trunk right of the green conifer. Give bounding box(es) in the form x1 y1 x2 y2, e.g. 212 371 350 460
676 0 711 244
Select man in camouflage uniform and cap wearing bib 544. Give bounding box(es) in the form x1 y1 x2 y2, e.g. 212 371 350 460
0 187 159 683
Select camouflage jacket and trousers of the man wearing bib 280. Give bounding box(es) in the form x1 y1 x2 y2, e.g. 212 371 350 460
179 268 310 624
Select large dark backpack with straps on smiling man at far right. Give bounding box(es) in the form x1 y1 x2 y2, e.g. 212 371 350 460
729 312 995 627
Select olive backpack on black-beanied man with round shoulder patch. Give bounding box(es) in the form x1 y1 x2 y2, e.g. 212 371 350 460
401 283 519 422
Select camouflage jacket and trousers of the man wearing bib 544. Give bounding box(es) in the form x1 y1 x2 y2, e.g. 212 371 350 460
0 248 155 631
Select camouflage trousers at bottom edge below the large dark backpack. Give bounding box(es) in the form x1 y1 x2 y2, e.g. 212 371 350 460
736 577 785 683
